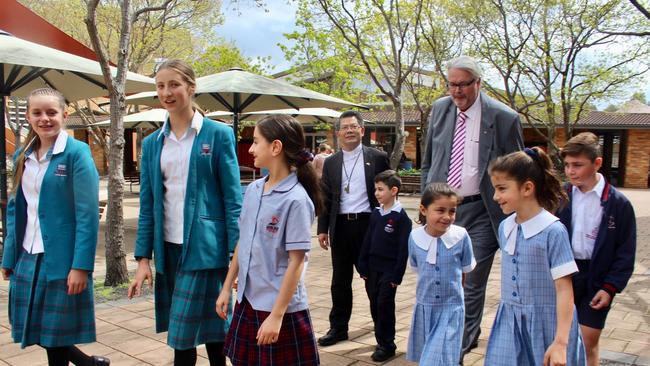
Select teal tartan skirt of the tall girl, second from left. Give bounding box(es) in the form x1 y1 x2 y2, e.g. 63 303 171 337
154 243 230 350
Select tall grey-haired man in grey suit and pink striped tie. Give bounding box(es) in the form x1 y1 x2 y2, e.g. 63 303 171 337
421 56 523 361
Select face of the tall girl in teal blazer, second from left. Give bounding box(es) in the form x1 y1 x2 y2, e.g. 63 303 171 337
156 68 195 114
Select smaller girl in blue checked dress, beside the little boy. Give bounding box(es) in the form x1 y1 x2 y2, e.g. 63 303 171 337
406 183 476 366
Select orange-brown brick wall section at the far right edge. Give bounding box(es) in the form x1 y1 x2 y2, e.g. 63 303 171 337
624 130 650 188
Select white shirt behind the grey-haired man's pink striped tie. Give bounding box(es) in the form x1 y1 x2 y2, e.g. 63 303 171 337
456 94 481 197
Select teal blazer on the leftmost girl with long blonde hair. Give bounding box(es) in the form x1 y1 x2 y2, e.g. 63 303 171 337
2 136 99 281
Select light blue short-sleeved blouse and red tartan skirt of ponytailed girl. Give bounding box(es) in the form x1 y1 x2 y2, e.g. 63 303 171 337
224 173 320 366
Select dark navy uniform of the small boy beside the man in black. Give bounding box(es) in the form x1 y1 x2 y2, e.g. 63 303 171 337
357 201 412 352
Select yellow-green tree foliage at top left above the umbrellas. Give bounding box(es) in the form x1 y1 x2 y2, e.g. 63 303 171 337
20 0 223 74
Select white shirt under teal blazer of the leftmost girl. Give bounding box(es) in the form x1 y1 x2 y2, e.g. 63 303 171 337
20 129 68 254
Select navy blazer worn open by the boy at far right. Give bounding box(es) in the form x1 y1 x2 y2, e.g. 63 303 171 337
557 182 636 292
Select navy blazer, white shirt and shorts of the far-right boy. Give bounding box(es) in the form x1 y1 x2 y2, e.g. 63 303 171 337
558 177 636 329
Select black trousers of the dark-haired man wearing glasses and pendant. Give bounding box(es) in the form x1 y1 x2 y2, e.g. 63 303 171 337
330 214 369 331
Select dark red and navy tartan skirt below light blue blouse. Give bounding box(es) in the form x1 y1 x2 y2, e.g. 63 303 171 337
223 298 320 366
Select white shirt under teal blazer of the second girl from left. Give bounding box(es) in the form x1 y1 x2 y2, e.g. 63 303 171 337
158 111 203 244
